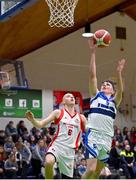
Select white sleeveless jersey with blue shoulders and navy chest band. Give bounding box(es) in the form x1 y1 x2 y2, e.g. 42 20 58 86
87 91 117 137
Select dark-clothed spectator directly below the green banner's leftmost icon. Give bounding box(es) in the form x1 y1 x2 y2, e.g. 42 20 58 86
5 121 18 142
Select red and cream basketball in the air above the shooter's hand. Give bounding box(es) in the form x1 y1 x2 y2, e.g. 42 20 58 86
93 29 111 48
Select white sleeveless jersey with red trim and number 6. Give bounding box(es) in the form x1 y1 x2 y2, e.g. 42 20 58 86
51 109 83 148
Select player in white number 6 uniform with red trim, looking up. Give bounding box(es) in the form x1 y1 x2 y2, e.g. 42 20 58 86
26 93 86 179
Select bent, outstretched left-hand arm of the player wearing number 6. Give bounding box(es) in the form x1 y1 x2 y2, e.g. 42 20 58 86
25 109 60 128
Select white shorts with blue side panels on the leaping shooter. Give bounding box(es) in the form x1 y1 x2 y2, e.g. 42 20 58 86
85 129 112 162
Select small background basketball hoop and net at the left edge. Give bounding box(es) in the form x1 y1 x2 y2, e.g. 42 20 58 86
0 71 10 89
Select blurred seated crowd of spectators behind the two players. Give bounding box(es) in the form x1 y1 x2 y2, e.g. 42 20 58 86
0 120 136 179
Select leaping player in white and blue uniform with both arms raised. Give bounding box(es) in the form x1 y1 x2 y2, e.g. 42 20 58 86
83 39 125 179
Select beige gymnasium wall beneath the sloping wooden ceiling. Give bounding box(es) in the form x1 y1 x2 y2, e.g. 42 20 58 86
0 13 136 131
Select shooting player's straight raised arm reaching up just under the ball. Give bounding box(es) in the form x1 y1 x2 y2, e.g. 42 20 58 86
88 38 97 96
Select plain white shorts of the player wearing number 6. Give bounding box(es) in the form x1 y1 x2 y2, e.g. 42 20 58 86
47 142 75 177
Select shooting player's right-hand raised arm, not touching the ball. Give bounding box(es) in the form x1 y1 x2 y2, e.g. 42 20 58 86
115 59 126 107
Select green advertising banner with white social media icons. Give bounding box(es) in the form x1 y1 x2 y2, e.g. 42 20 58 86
0 90 42 118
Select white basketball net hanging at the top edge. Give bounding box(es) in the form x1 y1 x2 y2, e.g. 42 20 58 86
45 0 78 28
